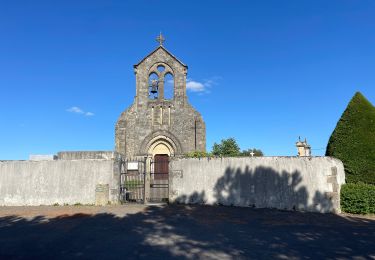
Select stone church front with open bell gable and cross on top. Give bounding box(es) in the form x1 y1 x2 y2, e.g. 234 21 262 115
115 34 206 158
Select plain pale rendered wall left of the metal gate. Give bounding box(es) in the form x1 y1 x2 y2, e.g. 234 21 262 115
0 160 120 206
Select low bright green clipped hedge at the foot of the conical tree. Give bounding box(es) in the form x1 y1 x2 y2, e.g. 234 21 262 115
341 183 375 214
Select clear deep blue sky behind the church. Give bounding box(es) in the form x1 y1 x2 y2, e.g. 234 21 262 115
0 0 375 159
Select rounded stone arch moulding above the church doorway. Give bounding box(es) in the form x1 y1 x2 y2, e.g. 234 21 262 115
139 131 182 156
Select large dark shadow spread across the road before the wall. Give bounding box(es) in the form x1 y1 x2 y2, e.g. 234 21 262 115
0 204 375 259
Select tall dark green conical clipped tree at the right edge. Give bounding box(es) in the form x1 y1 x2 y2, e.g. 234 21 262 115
326 92 375 184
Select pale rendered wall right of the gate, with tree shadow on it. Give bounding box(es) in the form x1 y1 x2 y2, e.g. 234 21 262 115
169 157 345 212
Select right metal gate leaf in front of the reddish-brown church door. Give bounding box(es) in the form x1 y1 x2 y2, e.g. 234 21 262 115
149 154 169 202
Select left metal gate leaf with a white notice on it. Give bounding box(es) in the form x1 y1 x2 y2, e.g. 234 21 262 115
120 160 146 203
